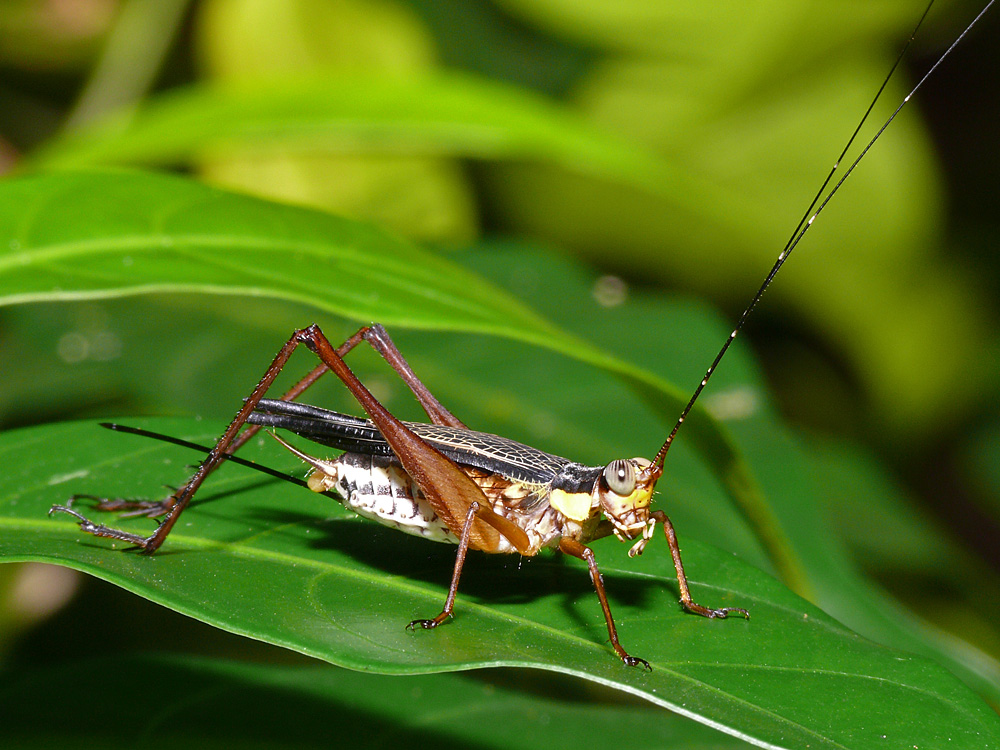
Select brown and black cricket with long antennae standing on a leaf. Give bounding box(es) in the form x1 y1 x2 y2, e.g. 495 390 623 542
50 0 993 669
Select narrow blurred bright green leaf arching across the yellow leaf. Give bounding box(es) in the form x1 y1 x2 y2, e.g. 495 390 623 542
30 72 732 224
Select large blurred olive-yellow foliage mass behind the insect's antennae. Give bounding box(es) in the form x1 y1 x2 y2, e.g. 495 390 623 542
487 0 990 449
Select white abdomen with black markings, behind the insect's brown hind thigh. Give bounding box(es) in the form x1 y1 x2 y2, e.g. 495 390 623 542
330 453 458 544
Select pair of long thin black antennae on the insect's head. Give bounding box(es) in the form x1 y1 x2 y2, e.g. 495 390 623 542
653 0 996 467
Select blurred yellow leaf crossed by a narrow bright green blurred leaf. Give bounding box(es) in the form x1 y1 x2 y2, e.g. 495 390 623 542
196 0 477 241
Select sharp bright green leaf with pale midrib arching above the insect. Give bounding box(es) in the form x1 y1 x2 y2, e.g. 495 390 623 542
0 172 806 591
